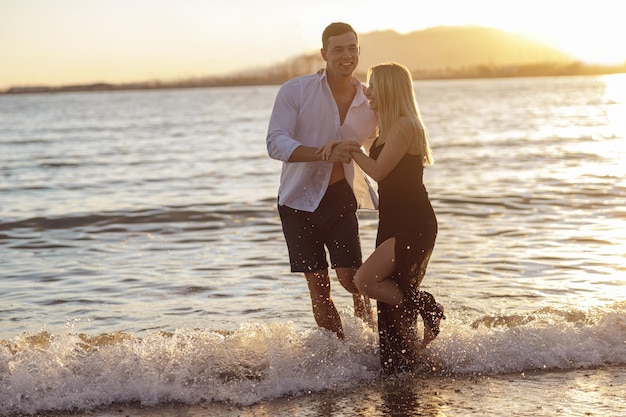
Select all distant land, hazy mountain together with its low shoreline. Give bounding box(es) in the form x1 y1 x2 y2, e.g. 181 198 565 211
6 26 626 94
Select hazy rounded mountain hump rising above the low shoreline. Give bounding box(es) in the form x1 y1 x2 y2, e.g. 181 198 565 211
255 26 575 78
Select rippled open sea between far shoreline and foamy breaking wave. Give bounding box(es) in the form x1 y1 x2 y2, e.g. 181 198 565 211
0 74 626 335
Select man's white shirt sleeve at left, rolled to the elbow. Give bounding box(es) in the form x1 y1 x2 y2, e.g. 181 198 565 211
266 84 301 162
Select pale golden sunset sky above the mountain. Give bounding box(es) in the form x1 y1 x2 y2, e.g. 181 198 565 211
0 0 626 89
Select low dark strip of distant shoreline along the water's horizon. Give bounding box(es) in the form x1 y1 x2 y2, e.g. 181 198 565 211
0 62 626 95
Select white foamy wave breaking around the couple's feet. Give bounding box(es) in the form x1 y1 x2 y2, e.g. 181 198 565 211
0 302 626 415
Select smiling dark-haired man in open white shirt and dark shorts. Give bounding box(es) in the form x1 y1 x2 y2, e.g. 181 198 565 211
267 23 377 338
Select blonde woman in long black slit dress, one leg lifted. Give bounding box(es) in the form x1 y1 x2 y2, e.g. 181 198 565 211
320 63 445 365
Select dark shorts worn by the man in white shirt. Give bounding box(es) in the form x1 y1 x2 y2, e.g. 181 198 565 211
278 180 362 272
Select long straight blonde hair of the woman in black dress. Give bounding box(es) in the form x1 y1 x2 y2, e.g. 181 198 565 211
367 62 434 166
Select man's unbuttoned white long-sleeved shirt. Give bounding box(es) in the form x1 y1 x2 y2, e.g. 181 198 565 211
266 71 378 212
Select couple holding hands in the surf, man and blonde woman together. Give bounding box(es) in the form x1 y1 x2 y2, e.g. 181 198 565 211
267 23 444 373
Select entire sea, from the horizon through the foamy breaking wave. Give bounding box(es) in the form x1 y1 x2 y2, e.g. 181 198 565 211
0 74 626 415
